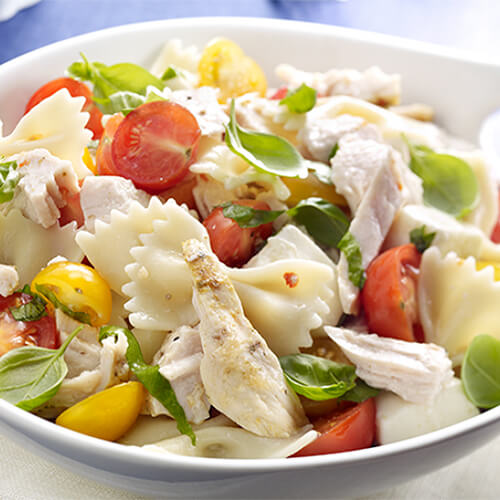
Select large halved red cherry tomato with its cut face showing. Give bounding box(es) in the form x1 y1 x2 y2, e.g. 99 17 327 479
111 101 201 194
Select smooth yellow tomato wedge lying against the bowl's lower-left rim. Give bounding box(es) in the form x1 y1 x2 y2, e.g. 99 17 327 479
56 382 144 441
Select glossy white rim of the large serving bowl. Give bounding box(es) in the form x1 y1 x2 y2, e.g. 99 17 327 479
0 16 500 475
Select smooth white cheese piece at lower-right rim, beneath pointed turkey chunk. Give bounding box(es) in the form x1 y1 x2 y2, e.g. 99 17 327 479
376 378 479 444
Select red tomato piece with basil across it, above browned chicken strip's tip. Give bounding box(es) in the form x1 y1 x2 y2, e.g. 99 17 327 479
203 200 273 267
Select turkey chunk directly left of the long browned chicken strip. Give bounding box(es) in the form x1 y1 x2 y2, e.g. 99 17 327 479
146 326 210 424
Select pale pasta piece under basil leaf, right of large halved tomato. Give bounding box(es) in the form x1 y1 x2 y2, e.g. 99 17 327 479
190 144 290 200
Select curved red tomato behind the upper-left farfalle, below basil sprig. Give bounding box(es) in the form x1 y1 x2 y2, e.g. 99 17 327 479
24 78 103 139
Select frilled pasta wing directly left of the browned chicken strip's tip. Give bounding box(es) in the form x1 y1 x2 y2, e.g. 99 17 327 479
123 199 210 330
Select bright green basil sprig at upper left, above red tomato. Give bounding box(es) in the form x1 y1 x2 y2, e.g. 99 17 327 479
66 54 165 113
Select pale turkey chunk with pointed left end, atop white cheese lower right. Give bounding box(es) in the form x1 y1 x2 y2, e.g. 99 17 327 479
325 326 453 404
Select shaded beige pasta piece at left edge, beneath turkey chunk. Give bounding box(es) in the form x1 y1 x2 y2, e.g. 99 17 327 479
0 209 83 284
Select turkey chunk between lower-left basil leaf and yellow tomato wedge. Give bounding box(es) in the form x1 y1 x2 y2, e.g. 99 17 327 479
42 309 129 414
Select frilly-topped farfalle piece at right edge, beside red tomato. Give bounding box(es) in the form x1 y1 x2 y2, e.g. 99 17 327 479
418 247 500 366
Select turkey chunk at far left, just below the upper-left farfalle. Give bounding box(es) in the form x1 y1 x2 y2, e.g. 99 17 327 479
2 149 79 228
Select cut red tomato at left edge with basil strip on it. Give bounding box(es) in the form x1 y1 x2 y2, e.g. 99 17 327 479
0 292 59 356
